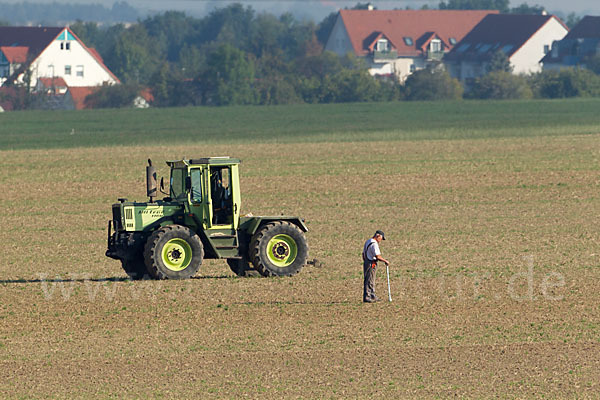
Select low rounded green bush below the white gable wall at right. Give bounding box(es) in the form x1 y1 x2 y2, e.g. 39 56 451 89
467 71 533 99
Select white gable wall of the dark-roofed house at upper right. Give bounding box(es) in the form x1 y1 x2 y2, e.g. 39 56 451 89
510 18 568 74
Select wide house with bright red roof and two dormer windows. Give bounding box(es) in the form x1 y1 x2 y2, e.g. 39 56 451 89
325 9 498 81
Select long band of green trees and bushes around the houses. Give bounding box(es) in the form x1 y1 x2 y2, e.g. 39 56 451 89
1 0 600 107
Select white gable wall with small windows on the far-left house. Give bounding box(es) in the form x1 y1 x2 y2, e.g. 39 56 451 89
31 30 117 87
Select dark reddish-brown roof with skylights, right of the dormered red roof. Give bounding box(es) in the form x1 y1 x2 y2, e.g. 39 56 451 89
445 14 568 61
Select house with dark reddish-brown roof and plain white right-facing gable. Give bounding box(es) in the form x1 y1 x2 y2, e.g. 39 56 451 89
444 14 569 81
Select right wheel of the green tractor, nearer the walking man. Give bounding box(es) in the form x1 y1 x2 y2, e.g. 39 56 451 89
249 221 308 276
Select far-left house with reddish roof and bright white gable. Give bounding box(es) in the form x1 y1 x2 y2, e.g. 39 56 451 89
0 26 120 89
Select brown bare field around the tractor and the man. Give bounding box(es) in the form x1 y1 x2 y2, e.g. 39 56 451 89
0 107 600 399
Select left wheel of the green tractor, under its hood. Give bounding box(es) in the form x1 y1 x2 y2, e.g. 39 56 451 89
144 225 204 279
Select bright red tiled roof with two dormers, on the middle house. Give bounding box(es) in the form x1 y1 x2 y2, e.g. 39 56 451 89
340 10 498 56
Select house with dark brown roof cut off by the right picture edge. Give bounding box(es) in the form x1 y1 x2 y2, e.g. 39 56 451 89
542 16 600 70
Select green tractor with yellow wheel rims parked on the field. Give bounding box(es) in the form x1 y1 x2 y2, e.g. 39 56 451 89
106 157 308 279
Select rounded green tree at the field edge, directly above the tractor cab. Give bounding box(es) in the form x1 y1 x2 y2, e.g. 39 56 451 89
201 44 255 106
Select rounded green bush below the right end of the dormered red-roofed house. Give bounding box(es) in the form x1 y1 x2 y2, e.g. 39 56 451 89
404 69 464 100
